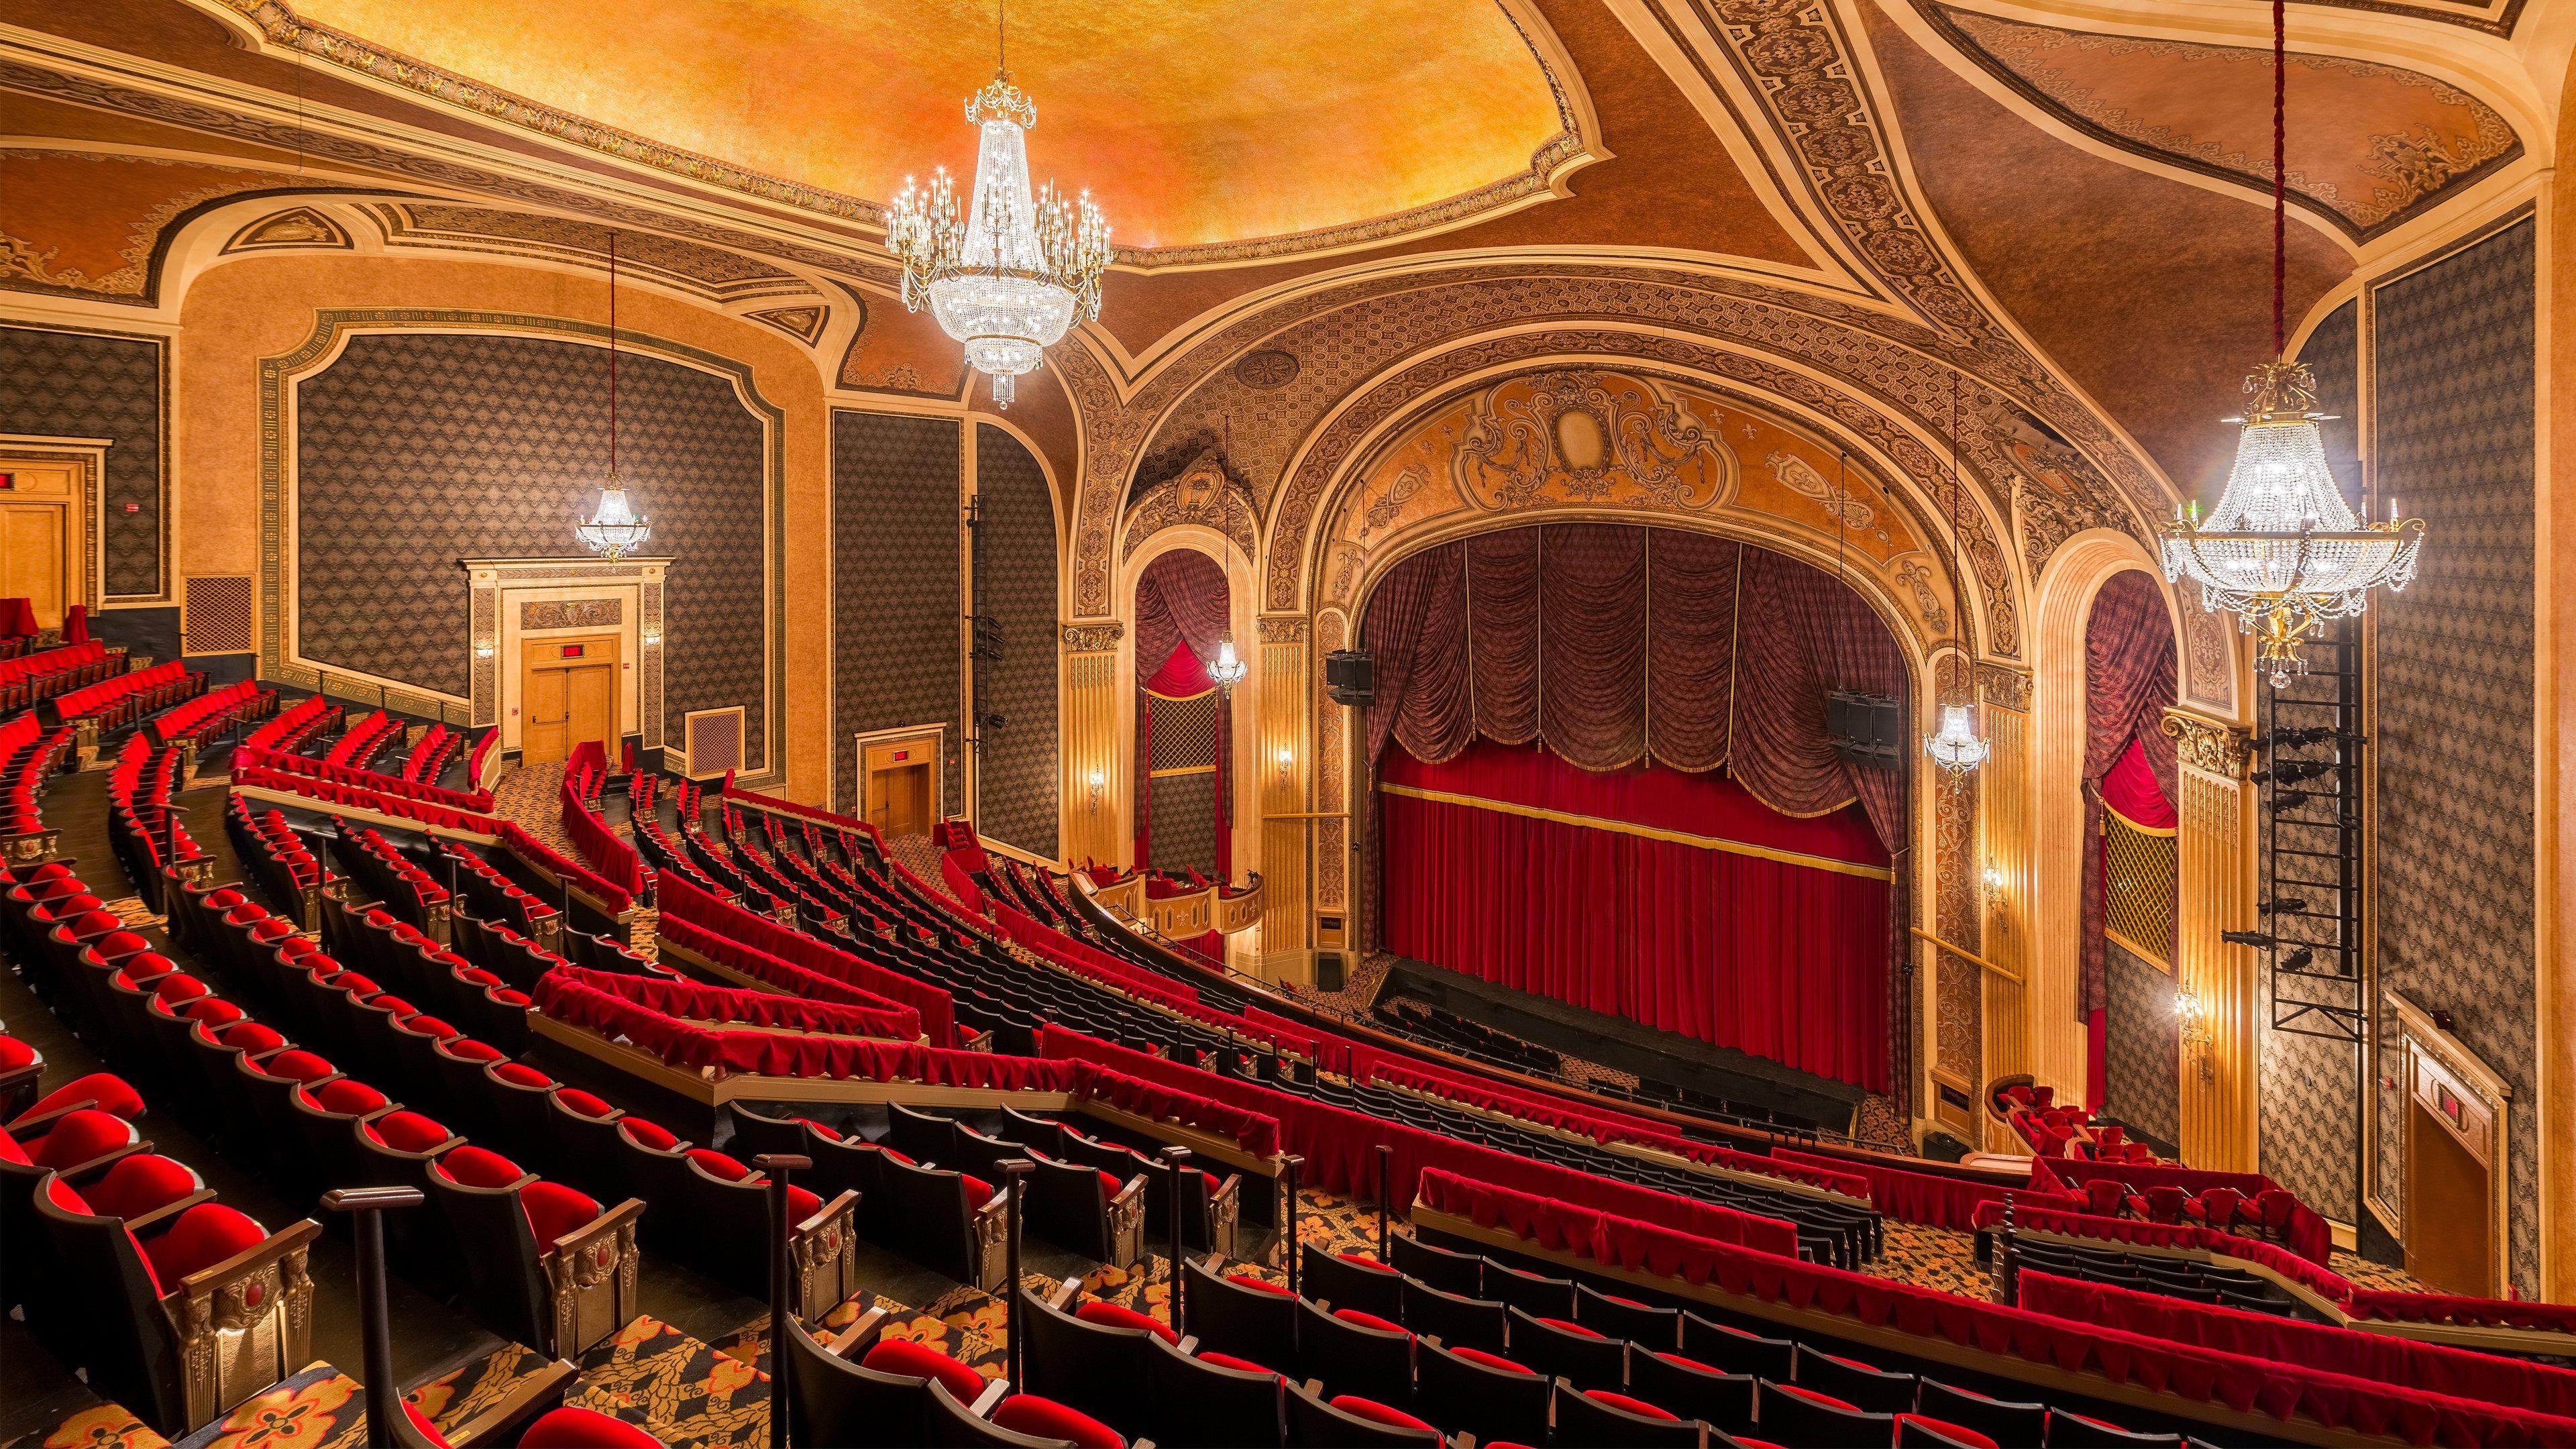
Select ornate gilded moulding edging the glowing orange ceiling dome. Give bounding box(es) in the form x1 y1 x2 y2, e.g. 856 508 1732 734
217 0 1607 271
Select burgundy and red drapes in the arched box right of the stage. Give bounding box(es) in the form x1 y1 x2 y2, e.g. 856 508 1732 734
2076 570 2174 1112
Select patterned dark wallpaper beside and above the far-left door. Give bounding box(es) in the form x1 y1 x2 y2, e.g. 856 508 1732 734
0 327 162 598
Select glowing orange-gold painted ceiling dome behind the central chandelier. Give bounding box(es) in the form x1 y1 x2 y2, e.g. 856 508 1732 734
294 0 1561 248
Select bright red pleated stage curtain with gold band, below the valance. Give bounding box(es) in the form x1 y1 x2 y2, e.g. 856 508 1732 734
1381 743 1888 1091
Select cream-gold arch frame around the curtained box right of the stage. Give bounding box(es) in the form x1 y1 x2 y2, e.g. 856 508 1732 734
2022 529 2190 1101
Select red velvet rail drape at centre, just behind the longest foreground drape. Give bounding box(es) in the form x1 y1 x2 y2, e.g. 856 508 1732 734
1038 1026 1798 1256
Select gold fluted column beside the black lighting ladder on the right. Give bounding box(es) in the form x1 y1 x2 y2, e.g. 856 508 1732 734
2164 709 2259 1173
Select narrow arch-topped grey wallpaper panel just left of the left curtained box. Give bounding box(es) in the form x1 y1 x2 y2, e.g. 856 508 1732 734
974 423 1059 859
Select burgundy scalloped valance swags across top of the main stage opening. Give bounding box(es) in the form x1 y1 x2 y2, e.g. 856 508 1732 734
1362 523 1911 853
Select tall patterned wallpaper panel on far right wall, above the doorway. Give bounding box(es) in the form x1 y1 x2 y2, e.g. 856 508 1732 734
2373 219 2540 1297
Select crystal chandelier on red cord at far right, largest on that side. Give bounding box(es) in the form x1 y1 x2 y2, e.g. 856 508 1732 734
2159 0 2424 688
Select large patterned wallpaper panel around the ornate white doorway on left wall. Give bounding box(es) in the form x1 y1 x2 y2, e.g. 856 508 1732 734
291 333 767 773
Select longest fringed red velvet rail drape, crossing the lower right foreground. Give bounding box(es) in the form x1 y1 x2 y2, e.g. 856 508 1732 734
1419 1171 2576 1449
